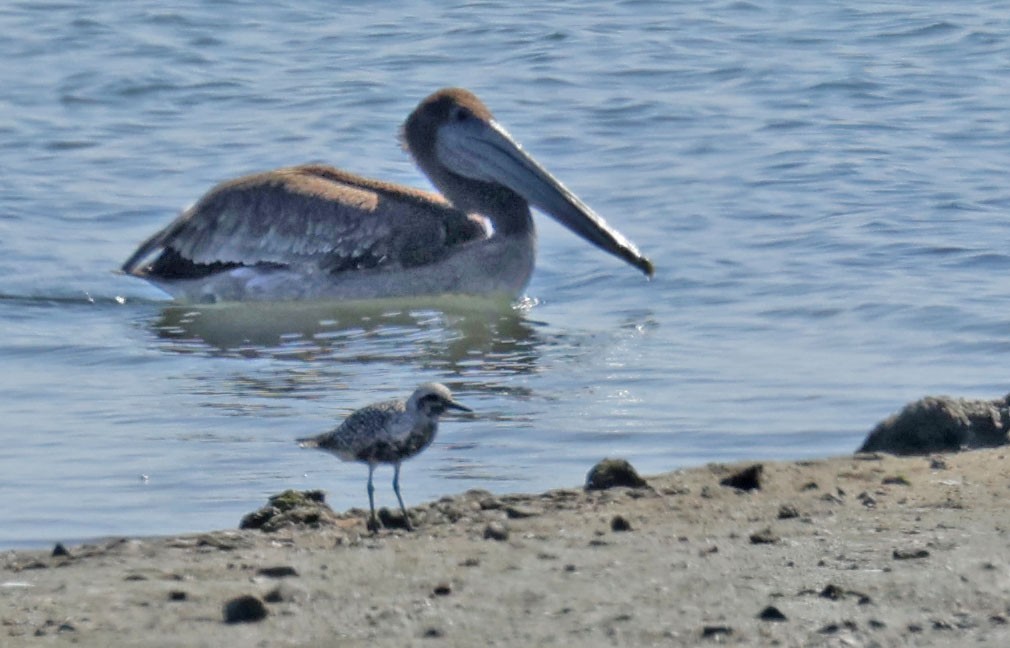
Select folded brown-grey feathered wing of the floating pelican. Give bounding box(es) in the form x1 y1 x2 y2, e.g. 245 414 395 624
123 165 477 274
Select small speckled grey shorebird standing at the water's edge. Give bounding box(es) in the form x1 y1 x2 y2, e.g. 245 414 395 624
298 383 473 531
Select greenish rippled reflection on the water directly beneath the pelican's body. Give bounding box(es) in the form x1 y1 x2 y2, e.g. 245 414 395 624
150 296 539 372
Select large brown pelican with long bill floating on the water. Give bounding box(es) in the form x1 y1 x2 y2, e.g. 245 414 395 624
122 88 652 302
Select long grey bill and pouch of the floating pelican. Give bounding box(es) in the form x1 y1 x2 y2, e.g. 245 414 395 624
435 119 653 277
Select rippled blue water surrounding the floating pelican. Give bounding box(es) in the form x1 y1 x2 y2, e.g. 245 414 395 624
0 0 1010 546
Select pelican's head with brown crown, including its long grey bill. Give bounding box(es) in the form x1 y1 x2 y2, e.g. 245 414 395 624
403 88 652 277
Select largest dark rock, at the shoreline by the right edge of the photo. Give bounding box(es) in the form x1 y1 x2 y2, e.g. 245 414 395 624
859 396 1010 454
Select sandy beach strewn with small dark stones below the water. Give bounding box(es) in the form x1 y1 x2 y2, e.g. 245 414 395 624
0 448 1010 647
